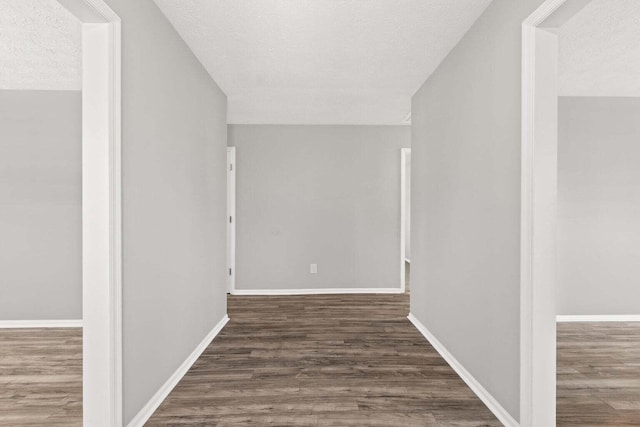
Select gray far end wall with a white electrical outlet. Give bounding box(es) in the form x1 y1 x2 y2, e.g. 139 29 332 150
229 125 410 289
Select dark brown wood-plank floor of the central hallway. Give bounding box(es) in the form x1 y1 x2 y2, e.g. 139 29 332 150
147 266 500 427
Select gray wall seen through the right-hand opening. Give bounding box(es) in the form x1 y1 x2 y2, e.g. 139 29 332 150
558 97 640 315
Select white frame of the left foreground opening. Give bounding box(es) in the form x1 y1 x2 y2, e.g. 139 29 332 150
58 0 123 427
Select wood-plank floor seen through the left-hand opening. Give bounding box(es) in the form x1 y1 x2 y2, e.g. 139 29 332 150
0 328 82 427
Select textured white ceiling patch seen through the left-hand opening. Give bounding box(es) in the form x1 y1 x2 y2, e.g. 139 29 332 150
0 0 82 90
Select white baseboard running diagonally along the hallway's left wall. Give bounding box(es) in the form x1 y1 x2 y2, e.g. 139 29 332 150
127 314 229 427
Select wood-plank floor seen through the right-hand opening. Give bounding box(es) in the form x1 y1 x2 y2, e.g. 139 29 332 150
557 323 640 427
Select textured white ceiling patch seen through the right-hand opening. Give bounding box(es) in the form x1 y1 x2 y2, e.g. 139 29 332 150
559 0 640 96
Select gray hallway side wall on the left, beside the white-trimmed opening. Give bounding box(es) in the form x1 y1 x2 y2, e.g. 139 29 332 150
102 0 227 424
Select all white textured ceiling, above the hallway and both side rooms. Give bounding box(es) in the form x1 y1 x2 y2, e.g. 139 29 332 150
0 0 640 108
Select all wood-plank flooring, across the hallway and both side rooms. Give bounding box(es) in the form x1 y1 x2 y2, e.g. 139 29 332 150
0 270 640 427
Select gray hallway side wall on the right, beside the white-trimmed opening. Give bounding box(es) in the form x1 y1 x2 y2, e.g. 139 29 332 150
411 0 542 420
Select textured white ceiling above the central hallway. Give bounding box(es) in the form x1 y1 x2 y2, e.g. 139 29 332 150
155 0 491 124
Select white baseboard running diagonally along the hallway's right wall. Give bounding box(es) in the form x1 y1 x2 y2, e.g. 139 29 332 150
407 314 519 427
